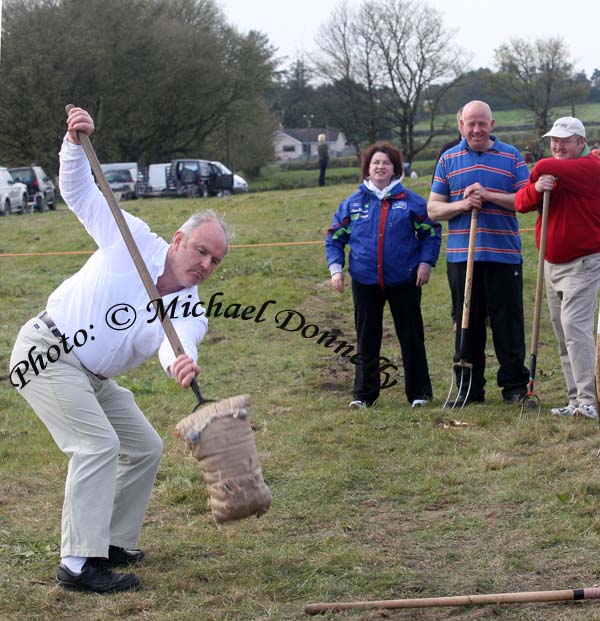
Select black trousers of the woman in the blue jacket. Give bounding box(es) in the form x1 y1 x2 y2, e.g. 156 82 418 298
352 281 433 404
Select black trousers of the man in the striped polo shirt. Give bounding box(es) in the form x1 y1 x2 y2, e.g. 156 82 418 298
447 261 529 398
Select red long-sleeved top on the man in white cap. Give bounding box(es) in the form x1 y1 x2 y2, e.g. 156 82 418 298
515 155 600 263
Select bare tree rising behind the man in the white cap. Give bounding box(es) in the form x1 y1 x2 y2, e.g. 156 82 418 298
494 37 588 158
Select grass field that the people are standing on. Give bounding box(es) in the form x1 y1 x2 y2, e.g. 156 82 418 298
0 185 600 621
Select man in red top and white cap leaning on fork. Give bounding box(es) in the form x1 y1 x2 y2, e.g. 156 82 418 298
515 117 600 418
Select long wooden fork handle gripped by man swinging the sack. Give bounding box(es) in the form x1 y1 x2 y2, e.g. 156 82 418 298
65 104 209 407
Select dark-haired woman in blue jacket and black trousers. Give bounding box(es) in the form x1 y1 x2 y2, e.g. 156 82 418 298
325 143 441 408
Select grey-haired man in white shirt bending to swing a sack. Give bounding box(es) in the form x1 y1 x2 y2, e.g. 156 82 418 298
10 108 231 593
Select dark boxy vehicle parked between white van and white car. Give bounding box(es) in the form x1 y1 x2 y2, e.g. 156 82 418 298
167 159 233 197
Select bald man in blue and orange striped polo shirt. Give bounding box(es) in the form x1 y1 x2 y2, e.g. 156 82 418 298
427 101 529 405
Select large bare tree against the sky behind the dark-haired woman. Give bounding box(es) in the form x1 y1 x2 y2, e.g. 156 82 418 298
317 0 470 161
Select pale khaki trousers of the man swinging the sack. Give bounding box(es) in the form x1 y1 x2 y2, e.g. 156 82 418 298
10 318 162 557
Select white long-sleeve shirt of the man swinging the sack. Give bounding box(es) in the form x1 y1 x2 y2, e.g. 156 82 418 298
46 138 208 377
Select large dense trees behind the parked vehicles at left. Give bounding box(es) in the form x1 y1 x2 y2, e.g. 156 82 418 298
0 0 274 170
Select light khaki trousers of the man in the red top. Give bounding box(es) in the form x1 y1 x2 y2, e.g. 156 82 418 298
544 253 600 405
